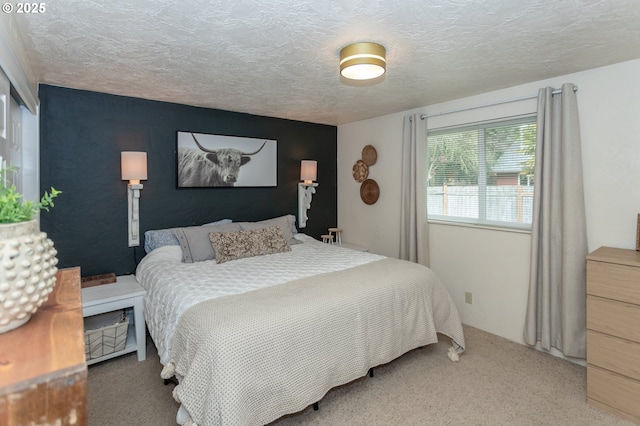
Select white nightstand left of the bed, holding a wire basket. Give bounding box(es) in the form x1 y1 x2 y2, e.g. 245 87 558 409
82 275 147 365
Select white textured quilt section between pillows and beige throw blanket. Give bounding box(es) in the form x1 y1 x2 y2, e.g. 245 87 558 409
136 234 384 365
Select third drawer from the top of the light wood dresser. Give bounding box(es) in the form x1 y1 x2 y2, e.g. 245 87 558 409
587 330 640 381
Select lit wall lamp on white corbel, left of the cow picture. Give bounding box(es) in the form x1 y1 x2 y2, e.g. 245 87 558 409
120 151 147 247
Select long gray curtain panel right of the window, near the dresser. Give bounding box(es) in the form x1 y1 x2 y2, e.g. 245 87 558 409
524 83 588 358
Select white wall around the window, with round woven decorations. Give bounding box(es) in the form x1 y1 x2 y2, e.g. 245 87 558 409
338 60 640 343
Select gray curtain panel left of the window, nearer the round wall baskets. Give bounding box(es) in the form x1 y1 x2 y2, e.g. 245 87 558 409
400 114 429 266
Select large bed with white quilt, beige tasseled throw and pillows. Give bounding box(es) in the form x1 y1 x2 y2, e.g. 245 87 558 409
136 218 465 426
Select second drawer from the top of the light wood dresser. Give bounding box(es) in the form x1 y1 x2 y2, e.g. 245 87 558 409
587 296 640 343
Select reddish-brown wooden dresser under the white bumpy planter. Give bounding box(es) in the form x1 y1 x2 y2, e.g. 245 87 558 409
0 268 87 426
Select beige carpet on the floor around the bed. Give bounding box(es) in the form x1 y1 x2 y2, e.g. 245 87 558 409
89 326 632 426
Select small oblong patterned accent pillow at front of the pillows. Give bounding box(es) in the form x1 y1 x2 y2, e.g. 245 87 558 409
209 226 291 263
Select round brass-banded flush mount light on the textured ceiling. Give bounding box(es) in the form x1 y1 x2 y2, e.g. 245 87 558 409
340 42 387 80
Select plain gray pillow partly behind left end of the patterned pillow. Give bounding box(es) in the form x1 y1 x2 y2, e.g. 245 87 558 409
173 223 240 263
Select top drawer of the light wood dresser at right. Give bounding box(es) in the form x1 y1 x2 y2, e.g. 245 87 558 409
587 261 640 305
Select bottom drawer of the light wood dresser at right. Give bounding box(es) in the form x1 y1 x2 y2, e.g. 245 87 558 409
587 366 640 422
